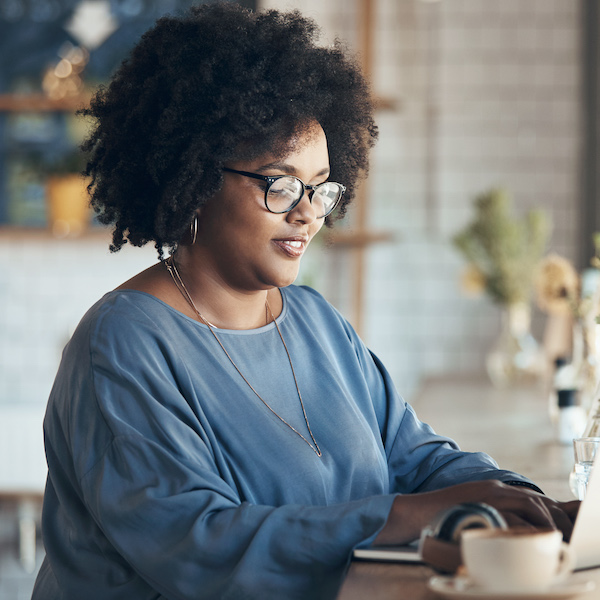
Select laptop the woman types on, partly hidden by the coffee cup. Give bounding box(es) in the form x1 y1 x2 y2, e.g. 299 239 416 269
353 458 600 571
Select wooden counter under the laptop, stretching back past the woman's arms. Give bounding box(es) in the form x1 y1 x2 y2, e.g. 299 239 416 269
338 377 600 600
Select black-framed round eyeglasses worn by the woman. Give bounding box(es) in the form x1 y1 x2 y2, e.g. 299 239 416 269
223 167 346 219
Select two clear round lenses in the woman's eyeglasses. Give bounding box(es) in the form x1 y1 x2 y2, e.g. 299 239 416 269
266 176 342 218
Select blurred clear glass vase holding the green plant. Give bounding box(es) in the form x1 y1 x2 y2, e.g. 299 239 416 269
486 302 544 388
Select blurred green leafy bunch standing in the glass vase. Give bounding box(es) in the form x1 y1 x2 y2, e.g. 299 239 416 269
453 189 550 305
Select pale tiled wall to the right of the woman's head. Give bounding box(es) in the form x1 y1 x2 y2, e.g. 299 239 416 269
263 0 581 398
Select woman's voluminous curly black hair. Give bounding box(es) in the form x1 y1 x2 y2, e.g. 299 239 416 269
80 2 377 258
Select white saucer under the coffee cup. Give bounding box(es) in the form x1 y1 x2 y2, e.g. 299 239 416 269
428 576 596 600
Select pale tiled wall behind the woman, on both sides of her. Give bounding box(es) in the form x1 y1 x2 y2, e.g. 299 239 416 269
0 0 580 600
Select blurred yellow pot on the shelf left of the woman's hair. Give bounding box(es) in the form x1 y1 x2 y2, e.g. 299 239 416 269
46 173 91 238
